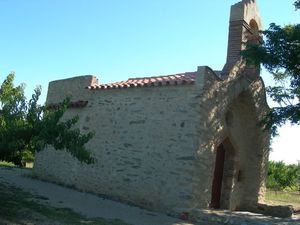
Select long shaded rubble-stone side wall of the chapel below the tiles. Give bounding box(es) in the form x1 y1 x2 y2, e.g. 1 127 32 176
34 85 205 211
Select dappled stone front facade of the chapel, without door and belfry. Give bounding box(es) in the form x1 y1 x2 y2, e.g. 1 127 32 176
193 62 270 210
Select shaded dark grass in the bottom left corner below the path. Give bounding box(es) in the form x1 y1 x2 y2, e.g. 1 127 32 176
0 184 128 225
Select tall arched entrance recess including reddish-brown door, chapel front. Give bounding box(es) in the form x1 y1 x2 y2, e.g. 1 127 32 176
210 91 269 210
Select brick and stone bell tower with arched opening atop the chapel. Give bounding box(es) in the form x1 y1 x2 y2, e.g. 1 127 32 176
222 0 262 77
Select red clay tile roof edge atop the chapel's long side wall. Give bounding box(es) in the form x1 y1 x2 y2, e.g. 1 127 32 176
87 72 196 90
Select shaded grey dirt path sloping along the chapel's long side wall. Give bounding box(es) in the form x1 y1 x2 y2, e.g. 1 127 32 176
0 167 192 225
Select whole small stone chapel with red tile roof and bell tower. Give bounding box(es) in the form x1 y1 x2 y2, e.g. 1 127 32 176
34 0 270 212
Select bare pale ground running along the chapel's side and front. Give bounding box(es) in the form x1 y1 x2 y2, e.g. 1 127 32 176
0 167 300 225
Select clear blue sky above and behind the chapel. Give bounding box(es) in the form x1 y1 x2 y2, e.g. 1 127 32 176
0 0 300 162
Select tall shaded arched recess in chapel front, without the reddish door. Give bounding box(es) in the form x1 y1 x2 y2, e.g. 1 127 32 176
223 91 269 209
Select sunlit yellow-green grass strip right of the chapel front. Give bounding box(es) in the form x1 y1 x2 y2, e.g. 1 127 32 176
266 190 300 208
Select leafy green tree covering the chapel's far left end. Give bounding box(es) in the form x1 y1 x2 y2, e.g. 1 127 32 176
0 73 93 166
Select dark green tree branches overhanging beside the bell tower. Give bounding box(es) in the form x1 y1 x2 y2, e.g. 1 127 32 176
242 0 300 135
